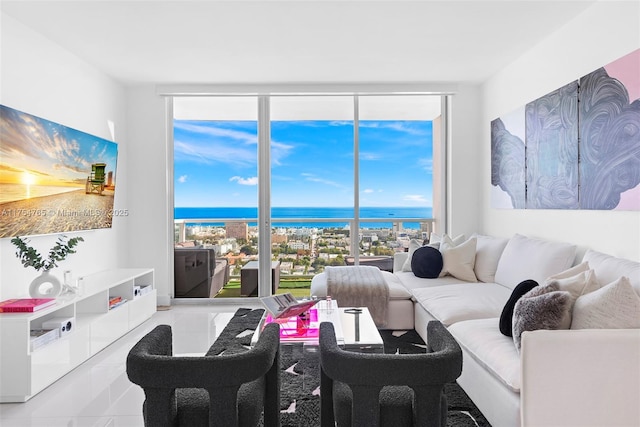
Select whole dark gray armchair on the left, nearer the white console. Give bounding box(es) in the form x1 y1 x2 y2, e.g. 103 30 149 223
127 324 280 427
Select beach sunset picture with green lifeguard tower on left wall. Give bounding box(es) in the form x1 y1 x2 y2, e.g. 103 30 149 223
0 105 118 238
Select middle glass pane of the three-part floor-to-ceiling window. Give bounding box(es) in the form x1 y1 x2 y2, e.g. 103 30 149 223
271 96 354 296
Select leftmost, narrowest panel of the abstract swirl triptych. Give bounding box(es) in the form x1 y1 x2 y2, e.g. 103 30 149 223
491 107 525 209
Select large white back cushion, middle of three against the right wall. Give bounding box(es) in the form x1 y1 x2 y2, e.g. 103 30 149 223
496 234 576 289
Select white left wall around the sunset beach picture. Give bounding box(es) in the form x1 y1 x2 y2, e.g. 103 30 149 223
0 12 128 300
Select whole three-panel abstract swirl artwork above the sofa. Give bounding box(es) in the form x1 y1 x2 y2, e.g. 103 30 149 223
491 49 640 210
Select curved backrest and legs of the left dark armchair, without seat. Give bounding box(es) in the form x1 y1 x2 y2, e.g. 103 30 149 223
127 324 280 427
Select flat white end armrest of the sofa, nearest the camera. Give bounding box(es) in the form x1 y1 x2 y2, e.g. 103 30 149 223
520 329 640 427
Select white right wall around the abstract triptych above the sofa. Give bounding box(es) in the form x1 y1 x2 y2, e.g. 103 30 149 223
477 1 640 261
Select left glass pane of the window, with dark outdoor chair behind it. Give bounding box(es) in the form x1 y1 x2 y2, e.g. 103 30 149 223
173 97 258 298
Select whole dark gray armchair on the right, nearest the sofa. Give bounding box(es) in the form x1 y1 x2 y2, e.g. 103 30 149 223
320 322 462 427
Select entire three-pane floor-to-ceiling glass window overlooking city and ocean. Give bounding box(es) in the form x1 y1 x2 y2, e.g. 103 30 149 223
173 94 441 298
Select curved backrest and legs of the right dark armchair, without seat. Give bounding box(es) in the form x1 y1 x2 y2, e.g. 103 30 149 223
320 322 462 426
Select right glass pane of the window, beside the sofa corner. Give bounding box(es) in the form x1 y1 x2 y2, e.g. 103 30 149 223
358 96 440 254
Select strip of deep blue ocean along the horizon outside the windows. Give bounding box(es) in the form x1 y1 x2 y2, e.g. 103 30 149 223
174 207 432 228
